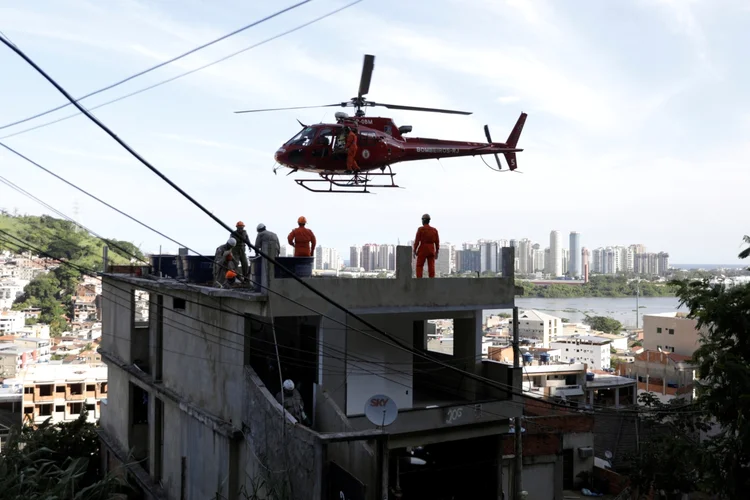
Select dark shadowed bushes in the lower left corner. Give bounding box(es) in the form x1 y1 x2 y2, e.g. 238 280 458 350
0 409 128 500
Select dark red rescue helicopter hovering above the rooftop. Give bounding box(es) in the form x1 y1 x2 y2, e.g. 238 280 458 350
235 54 527 193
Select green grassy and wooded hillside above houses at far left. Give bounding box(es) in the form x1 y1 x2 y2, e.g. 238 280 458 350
0 213 144 335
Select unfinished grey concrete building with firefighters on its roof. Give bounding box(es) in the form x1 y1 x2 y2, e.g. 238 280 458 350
99 246 592 500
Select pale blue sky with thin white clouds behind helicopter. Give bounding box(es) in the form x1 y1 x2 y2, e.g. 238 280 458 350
0 0 750 264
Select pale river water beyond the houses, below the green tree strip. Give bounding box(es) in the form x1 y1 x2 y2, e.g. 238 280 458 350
484 297 686 328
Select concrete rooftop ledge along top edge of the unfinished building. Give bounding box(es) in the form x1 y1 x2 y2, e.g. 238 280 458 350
103 246 521 316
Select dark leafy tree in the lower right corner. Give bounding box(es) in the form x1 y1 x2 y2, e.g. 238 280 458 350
630 236 750 499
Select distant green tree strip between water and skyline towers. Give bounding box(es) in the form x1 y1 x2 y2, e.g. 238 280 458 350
517 275 674 299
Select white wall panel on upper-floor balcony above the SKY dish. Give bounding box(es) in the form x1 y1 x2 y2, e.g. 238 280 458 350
341 315 414 415
